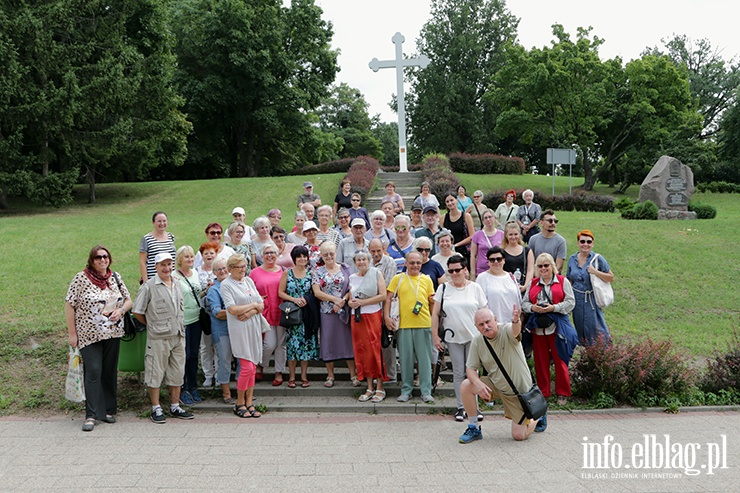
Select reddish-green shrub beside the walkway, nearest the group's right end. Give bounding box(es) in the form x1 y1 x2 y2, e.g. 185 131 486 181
570 338 694 405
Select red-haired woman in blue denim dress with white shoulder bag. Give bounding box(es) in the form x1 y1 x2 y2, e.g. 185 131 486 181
566 229 614 346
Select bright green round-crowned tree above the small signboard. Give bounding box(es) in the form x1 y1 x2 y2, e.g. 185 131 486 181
486 24 621 190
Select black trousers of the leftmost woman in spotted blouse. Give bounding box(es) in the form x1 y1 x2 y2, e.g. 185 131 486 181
80 337 121 419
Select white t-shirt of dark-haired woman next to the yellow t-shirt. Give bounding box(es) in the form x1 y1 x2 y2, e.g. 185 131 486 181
434 282 486 344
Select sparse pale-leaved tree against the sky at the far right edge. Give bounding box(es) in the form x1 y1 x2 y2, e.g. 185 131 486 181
646 35 740 139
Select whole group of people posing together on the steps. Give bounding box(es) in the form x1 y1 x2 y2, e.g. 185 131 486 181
65 180 614 443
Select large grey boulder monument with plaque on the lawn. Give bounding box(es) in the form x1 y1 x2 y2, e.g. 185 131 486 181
638 156 696 219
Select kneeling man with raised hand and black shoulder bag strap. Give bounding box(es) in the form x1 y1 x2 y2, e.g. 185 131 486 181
460 306 537 443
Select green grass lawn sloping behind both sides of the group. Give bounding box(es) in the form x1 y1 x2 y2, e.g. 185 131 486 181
0 173 740 413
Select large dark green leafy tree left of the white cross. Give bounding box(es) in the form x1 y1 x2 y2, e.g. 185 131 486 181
172 0 337 176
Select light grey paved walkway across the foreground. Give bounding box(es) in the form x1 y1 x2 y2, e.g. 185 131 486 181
0 411 740 493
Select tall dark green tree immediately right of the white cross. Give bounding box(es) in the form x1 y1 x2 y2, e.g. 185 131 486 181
406 0 519 153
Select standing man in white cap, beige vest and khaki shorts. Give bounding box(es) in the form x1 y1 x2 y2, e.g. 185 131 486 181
131 253 193 424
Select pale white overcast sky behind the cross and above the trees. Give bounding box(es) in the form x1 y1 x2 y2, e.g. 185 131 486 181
316 0 740 121
